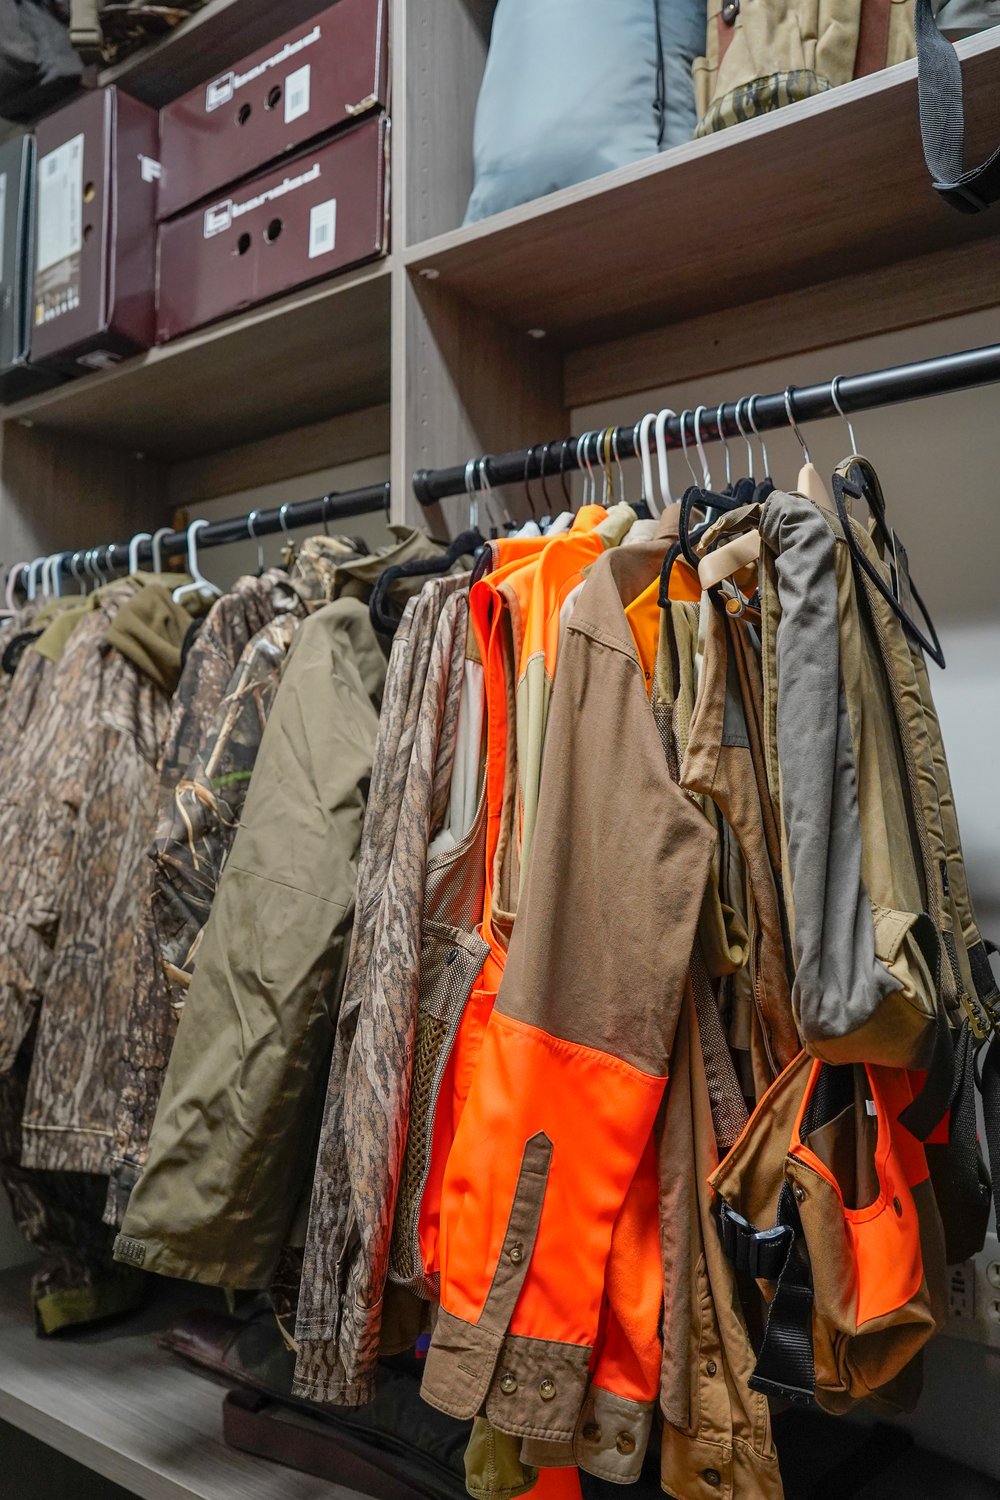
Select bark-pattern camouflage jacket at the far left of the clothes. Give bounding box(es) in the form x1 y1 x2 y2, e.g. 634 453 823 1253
1 579 183 1173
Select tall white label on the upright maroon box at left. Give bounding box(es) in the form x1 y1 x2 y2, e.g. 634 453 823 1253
34 134 84 323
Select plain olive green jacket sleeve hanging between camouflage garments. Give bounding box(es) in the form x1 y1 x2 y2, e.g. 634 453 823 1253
115 600 385 1287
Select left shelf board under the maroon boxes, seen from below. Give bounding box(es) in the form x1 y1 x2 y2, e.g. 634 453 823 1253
0 260 390 462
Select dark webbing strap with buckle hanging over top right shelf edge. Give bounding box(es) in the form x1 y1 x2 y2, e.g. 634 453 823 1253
913 0 1000 213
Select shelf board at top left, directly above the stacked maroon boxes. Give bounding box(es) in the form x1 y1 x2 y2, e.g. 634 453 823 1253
99 0 330 110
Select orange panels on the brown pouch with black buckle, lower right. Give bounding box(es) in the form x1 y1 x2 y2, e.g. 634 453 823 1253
792 1061 927 1328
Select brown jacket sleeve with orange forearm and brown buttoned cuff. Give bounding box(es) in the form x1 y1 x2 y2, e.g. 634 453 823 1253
423 603 715 1443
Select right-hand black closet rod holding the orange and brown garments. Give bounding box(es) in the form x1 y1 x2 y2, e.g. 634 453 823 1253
412 344 1000 506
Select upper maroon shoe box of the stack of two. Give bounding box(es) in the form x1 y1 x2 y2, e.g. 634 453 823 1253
157 0 388 219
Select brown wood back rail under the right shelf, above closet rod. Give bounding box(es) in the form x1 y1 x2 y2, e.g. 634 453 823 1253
565 239 1000 408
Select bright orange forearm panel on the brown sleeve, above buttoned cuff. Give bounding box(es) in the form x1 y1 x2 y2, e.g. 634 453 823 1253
441 1010 666 1346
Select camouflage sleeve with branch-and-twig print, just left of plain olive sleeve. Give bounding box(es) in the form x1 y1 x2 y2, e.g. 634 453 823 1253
105 536 354 1226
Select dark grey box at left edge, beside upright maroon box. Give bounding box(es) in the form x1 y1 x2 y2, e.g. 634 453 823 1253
0 135 60 402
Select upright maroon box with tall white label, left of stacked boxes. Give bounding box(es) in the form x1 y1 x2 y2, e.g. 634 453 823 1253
31 89 159 374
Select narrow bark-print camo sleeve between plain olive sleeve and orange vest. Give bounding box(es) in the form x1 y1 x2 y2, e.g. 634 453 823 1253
295 576 469 1406
